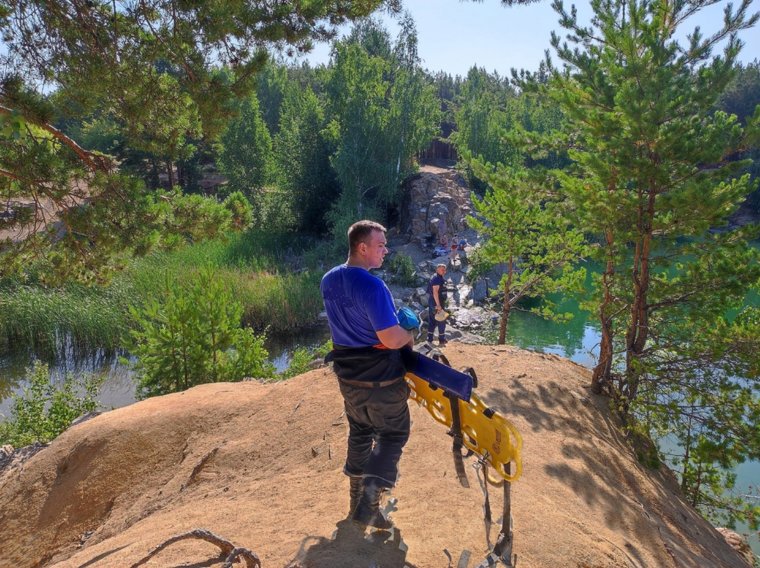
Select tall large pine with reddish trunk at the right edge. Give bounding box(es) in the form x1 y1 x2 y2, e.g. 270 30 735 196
548 0 760 524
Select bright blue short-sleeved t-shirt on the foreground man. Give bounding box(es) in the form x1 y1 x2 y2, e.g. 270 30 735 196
319 264 398 347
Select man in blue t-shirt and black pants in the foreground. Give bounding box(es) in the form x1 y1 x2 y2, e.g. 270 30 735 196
320 220 414 529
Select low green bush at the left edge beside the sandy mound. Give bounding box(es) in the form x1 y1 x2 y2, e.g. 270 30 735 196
0 361 103 448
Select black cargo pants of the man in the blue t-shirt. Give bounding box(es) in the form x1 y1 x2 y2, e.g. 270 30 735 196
338 378 410 487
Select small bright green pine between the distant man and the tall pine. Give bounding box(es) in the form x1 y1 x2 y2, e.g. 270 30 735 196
467 159 588 345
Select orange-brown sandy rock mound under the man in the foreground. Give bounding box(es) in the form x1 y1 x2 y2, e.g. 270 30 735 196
0 343 749 568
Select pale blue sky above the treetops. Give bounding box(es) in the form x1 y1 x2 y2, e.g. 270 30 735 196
296 0 760 77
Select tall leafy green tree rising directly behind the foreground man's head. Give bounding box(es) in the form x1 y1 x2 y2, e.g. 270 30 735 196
328 21 440 234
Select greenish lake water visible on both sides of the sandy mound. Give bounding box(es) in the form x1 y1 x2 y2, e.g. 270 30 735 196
0 302 760 556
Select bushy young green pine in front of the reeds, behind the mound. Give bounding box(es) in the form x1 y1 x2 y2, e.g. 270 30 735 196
128 269 274 398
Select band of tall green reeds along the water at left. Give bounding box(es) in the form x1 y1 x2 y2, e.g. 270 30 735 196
0 232 330 352
